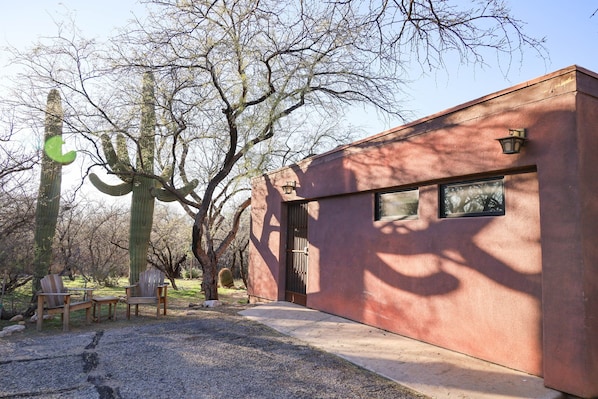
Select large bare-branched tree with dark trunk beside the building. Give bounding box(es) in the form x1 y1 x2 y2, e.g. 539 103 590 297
4 0 543 299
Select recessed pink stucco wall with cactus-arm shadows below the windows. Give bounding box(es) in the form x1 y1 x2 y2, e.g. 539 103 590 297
308 173 542 374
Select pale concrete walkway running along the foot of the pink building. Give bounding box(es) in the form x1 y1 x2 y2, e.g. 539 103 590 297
240 302 565 399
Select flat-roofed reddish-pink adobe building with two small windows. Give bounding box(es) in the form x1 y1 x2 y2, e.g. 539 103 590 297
248 66 598 398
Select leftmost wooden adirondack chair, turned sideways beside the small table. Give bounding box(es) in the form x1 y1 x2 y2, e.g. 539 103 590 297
37 274 93 331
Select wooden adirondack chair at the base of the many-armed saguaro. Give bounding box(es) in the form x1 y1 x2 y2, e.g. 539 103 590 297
125 269 168 319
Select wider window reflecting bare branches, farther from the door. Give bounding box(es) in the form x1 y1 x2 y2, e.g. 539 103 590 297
440 177 505 218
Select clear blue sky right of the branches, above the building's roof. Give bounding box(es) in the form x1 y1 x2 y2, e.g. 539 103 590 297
394 0 598 128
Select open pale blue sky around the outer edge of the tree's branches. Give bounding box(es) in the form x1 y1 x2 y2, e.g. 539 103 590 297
0 0 598 135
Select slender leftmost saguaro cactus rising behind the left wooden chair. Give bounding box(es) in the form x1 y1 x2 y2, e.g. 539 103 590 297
33 89 66 295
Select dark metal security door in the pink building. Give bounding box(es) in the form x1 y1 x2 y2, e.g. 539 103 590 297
285 202 309 306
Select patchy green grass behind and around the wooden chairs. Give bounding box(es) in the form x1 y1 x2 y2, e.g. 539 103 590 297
0 277 247 333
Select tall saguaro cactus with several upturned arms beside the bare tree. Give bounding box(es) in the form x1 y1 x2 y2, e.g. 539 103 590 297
89 72 197 284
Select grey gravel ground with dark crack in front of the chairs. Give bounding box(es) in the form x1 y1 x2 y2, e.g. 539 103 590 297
0 311 432 399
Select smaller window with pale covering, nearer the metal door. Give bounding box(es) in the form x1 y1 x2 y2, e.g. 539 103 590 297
376 188 419 220
